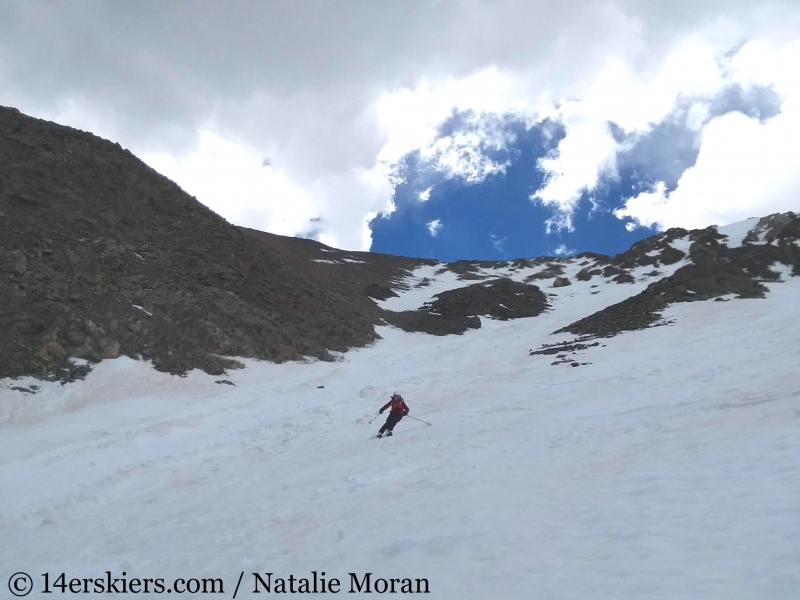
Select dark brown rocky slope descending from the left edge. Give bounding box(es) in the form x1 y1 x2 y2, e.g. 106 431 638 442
0 108 382 378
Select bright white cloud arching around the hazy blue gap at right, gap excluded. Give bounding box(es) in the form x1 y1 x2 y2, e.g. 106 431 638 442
531 39 800 231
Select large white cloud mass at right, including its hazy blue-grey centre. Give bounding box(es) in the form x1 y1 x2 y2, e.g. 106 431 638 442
531 36 800 231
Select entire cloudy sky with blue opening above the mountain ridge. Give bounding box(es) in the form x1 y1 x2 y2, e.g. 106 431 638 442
0 0 800 260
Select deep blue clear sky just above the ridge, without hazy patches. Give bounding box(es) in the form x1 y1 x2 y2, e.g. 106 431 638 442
370 115 656 261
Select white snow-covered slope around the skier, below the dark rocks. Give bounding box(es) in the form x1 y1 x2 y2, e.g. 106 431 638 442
0 262 800 600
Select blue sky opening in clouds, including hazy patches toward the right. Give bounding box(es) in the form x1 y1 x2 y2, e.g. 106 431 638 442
370 79 780 261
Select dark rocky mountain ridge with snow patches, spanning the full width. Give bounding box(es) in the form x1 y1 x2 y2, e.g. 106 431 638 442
0 107 800 381
